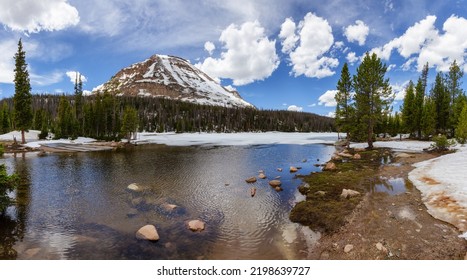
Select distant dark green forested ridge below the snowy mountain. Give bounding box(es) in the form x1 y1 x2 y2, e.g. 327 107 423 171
0 93 335 140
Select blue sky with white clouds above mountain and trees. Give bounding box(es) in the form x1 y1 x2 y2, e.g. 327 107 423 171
0 0 467 115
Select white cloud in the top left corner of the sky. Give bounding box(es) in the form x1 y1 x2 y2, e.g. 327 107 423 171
0 0 79 33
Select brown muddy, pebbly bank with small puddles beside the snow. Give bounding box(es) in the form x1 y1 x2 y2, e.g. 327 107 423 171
296 150 467 260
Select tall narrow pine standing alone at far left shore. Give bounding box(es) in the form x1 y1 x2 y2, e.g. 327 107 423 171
13 39 33 144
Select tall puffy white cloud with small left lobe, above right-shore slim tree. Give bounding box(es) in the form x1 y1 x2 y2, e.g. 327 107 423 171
280 13 339 78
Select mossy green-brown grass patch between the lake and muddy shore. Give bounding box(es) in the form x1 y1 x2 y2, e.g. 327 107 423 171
290 149 389 233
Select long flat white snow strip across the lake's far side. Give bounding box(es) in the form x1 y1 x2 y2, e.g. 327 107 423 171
134 132 337 146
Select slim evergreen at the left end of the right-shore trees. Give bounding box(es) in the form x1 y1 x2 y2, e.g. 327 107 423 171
334 63 353 143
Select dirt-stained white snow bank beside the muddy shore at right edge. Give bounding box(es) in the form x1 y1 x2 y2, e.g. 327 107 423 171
409 147 467 239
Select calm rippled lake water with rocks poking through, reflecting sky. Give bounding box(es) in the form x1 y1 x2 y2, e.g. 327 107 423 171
0 144 334 259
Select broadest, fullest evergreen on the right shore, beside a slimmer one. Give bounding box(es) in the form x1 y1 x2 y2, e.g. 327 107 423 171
353 53 393 149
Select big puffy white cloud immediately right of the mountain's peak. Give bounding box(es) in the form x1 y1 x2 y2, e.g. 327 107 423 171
196 21 279 86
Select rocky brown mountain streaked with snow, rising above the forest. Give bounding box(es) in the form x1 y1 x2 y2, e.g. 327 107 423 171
94 55 254 107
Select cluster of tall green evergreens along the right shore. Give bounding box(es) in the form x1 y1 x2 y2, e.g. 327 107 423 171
335 53 467 148
